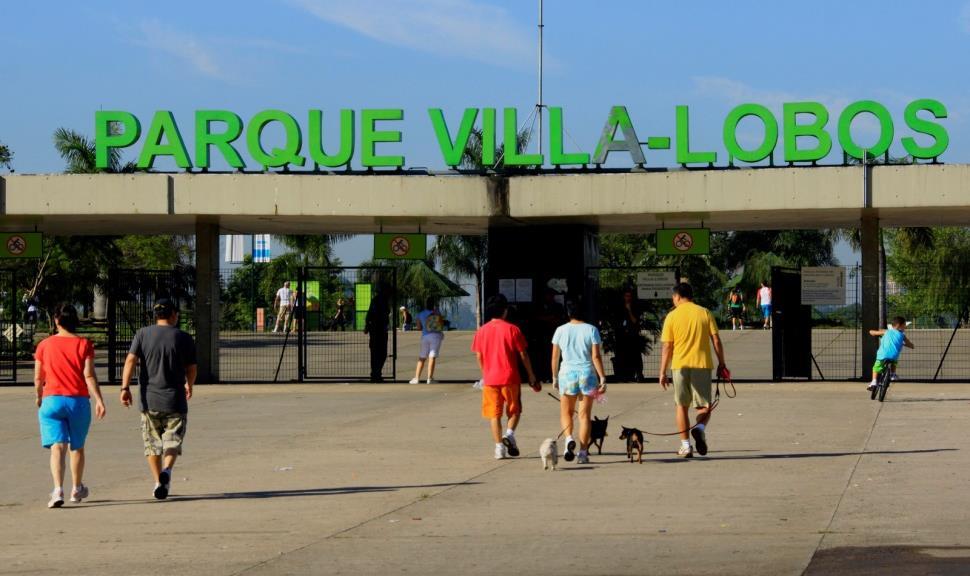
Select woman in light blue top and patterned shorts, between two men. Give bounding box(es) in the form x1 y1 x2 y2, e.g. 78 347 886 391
552 300 606 464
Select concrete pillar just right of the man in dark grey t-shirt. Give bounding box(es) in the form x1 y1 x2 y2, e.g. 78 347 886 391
195 221 219 384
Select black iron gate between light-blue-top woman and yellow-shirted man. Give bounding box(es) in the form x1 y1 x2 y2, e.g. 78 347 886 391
586 266 680 382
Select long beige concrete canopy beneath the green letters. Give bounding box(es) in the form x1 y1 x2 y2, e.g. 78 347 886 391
0 164 970 234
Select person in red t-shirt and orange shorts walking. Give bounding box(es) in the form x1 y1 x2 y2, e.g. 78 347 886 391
472 294 542 460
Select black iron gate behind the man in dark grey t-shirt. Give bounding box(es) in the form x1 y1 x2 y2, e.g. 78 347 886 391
108 268 195 382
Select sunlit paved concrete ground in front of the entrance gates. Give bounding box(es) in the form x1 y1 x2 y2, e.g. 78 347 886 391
0 383 970 576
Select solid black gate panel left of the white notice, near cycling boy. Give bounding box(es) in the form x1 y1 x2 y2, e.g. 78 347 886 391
771 267 812 380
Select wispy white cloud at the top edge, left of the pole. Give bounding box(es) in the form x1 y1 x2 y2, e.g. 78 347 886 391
289 0 535 68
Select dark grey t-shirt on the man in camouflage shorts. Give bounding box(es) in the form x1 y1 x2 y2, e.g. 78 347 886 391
128 324 196 414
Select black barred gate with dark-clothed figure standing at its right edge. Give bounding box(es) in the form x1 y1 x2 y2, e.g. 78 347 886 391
293 266 398 381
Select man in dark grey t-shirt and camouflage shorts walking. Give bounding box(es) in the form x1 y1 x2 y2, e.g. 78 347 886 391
121 298 197 500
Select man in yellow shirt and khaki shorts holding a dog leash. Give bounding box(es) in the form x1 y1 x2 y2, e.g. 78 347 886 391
660 282 725 458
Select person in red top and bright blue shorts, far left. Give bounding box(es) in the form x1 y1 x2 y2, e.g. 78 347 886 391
34 304 105 508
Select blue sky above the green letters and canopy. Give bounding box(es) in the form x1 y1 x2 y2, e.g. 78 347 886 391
0 0 970 262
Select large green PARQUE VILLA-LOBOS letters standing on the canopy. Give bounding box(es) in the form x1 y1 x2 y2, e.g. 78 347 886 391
95 99 949 170
